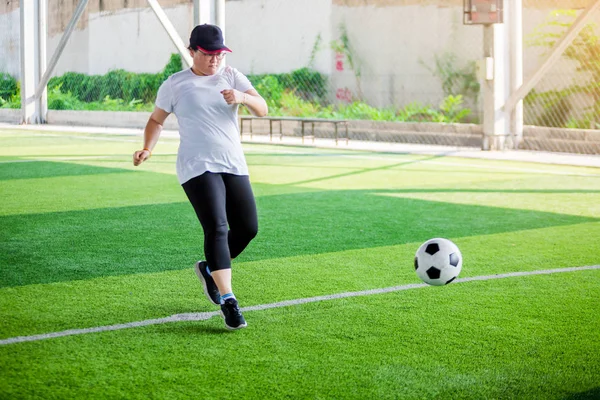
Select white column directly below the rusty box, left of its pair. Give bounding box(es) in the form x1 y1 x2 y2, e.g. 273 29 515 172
482 24 508 150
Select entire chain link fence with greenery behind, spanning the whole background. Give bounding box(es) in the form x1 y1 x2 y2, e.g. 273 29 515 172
0 0 600 153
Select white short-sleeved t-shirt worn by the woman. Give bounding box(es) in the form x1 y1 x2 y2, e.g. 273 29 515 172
156 67 253 184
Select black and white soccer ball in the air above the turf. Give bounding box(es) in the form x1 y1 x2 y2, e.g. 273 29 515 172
415 238 462 286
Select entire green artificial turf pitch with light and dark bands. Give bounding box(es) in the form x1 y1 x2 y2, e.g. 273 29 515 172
0 130 600 399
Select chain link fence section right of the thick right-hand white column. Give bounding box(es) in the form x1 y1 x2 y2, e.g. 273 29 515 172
521 0 600 154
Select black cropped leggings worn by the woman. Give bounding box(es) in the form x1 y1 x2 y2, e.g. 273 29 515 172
182 172 258 271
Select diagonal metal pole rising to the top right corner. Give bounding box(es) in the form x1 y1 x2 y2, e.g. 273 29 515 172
504 0 600 112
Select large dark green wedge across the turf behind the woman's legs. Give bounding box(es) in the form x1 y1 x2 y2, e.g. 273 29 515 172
0 184 598 287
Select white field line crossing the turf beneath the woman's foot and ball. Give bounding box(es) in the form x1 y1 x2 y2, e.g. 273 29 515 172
0 265 600 346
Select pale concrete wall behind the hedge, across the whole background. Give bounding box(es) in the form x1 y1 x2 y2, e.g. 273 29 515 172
0 0 600 111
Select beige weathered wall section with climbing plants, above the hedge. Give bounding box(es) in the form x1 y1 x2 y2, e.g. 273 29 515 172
332 4 483 106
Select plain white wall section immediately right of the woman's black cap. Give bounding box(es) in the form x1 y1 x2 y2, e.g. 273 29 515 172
225 0 332 74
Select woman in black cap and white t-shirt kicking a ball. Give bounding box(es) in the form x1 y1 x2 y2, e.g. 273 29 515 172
133 24 268 329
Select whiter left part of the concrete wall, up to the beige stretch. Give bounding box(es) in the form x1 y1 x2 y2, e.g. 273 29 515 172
0 0 331 76
